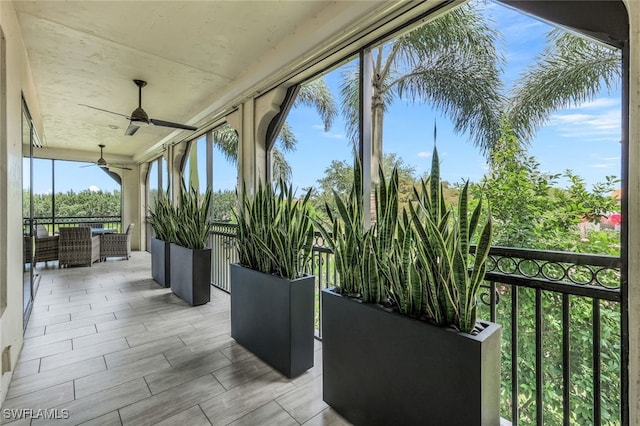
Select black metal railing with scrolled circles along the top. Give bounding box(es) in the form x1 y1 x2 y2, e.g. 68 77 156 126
211 223 627 425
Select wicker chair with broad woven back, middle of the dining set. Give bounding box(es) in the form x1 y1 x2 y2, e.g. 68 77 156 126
58 226 100 267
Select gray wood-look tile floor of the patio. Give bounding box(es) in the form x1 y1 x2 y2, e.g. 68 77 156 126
0 252 347 426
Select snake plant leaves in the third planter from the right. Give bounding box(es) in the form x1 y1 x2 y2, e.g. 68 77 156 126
174 182 211 250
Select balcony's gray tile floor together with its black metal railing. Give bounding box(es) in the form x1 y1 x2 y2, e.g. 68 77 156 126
3 223 626 424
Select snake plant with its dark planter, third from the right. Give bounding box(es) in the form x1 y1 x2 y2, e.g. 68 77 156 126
170 183 211 306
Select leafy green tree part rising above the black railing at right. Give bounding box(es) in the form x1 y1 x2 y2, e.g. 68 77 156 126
476 121 619 253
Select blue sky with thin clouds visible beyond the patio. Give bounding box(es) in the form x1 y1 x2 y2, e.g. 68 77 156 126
34 3 621 192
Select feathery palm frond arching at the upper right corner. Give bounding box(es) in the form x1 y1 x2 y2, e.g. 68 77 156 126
507 29 622 141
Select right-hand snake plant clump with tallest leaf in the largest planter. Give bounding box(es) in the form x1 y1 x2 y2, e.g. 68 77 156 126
409 148 492 333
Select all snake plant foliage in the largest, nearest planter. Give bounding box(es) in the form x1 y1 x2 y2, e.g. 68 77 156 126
320 148 491 333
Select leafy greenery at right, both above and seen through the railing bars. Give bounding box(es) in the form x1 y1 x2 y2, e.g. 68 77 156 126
476 121 620 425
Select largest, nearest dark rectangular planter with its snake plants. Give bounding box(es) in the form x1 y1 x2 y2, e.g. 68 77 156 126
322 149 501 425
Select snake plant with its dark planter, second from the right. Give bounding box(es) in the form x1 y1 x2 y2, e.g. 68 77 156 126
231 180 315 377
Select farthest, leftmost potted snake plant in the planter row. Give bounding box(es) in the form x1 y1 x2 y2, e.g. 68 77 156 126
148 191 176 287
